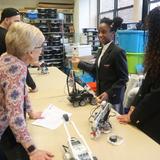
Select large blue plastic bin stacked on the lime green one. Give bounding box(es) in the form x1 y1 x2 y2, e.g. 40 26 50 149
116 30 147 53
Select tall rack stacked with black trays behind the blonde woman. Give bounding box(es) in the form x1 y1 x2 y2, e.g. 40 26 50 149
36 9 65 69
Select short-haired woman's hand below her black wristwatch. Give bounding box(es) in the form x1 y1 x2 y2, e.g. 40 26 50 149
29 150 54 160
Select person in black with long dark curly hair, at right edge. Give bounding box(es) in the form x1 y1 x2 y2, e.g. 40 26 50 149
117 7 160 144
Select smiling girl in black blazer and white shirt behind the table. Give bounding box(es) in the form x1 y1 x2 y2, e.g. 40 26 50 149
72 17 128 109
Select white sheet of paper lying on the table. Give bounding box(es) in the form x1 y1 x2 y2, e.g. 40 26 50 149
32 104 71 129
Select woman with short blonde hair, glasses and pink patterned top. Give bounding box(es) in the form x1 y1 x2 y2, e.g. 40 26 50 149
0 22 53 160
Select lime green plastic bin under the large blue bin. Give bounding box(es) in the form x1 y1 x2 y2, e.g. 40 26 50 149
127 53 144 73
